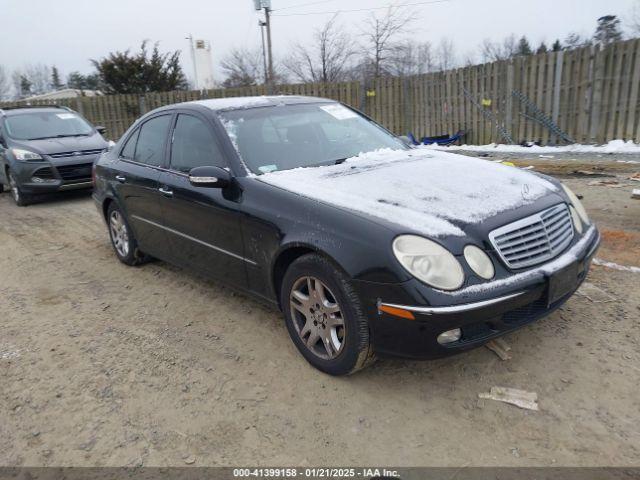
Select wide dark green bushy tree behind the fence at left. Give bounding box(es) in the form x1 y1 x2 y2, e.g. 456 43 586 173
91 41 188 93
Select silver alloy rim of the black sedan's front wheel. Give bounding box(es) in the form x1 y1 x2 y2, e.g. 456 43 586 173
290 277 345 360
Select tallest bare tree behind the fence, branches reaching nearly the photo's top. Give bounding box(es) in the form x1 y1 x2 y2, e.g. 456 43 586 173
363 7 415 78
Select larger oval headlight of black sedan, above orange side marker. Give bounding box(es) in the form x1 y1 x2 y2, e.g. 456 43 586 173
393 235 464 290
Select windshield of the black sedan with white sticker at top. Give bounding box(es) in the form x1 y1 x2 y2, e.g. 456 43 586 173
219 103 407 175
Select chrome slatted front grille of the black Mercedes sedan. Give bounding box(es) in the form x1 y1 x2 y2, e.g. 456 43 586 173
489 203 574 269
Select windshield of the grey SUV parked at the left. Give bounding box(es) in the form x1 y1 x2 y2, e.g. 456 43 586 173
5 110 93 140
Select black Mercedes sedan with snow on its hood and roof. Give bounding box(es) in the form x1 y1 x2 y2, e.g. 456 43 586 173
94 97 600 375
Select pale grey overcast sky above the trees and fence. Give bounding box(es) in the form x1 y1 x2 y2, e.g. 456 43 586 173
0 0 638 79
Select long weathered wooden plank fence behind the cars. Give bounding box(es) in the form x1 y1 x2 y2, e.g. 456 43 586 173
0 39 640 145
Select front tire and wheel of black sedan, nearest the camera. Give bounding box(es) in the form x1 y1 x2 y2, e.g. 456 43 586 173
280 254 375 376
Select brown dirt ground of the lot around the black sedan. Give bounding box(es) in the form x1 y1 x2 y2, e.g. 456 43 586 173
0 155 640 466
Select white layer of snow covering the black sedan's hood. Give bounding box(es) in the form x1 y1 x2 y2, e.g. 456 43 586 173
257 149 557 237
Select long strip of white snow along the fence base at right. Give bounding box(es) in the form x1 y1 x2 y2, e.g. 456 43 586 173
418 140 640 154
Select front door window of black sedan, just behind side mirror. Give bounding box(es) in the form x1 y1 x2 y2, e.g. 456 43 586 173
171 114 227 173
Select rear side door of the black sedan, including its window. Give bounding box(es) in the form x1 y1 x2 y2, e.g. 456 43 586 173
113 113 173 259
